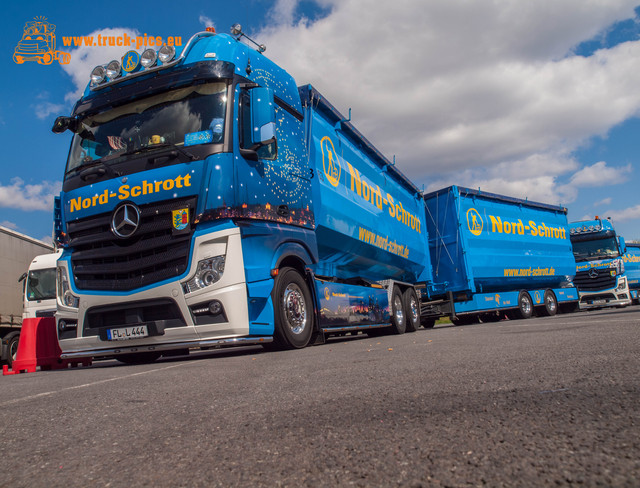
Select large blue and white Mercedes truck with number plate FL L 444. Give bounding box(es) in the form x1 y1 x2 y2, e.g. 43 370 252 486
53 26 430 362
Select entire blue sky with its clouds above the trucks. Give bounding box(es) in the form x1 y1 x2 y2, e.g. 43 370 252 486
0 0 640 244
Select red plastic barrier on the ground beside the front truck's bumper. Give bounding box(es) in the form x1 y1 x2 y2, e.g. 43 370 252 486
2 317 91 375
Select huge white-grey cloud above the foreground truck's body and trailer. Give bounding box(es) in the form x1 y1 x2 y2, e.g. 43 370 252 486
255 0 640 202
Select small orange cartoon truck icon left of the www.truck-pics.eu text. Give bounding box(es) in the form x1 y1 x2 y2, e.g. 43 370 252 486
13 17 71 65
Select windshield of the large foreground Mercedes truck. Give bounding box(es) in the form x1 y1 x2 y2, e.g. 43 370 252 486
66 82 227 174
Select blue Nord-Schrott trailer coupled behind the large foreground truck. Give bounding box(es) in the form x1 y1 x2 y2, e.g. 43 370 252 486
422 186 578 326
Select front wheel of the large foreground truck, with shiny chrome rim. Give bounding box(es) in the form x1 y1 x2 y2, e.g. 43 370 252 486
272 268 313 349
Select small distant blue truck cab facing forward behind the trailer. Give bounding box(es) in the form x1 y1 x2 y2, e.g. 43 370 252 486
569 217 631 309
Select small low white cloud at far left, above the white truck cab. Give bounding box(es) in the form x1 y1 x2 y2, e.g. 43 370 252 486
0 178 62 211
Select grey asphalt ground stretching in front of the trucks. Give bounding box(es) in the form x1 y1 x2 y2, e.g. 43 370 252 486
0 307 640 487
